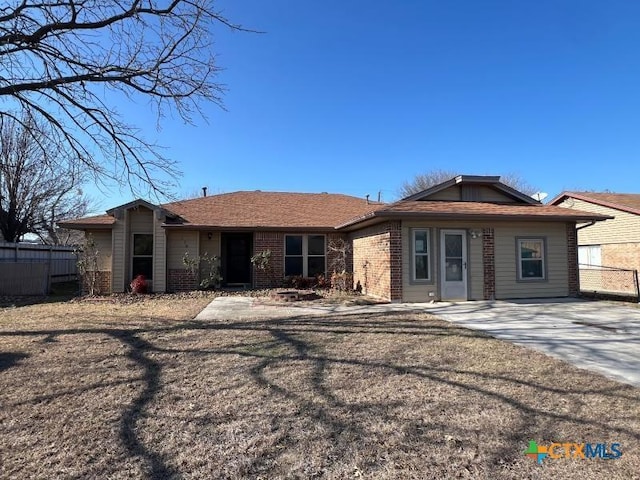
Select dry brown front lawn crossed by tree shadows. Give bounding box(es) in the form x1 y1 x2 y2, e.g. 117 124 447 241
0 296 640 479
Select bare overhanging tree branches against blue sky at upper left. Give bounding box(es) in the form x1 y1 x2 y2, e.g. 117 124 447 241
0 0 242 193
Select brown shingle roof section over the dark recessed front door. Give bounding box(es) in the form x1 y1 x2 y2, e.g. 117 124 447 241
162 191 383 229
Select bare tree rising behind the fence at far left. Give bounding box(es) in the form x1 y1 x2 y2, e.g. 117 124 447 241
0 115 89 244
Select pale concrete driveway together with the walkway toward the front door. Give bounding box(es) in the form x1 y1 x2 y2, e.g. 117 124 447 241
196 297 640 387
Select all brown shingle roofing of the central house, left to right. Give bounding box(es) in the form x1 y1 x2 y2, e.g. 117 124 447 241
60 191 611 230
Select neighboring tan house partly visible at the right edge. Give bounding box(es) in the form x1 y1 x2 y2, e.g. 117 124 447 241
549 192 640 289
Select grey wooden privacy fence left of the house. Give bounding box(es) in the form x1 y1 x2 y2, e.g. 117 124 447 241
0 242 78 295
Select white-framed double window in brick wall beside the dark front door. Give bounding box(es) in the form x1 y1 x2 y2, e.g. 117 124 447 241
284 235 327 277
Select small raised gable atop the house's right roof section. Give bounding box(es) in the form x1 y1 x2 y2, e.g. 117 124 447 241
401 175 540 205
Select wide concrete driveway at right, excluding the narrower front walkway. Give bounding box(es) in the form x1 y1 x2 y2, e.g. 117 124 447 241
426 299 640 387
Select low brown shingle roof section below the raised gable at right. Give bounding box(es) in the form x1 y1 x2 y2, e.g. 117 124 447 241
340 201 612 227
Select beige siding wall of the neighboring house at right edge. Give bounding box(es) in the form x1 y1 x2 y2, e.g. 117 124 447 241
558 199 640 245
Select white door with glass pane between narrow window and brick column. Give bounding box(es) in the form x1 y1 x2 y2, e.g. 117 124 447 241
440 230 467 300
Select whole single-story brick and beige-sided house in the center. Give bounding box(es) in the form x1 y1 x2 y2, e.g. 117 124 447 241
61 176 609 301
